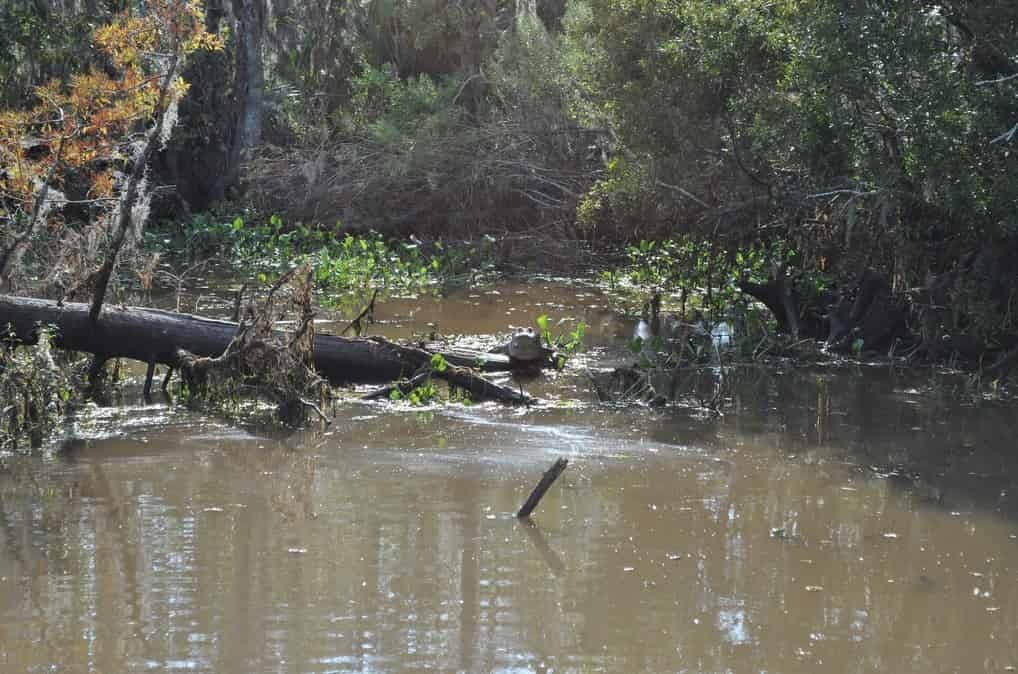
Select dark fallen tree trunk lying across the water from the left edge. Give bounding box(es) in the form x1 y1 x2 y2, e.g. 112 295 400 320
0 295 533 403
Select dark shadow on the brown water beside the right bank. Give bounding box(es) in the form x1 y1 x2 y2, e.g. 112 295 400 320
708 367 1018 518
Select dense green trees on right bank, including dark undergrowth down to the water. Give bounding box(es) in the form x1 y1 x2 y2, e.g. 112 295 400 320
565 0 1018 355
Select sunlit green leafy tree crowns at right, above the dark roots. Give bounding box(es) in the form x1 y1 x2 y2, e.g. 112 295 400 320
567 0 1018 254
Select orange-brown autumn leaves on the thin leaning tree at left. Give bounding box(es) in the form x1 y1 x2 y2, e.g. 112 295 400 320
0 0 223 227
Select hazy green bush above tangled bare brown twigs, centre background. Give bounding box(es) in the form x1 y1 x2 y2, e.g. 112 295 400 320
246 14 600 238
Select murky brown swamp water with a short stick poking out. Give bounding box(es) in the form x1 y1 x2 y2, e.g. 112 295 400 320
0 285 1018 674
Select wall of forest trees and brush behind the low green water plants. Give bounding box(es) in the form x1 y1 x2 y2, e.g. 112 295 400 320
0 0 1018 370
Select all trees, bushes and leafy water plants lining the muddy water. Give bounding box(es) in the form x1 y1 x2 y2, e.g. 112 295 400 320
0 0 1018 446
